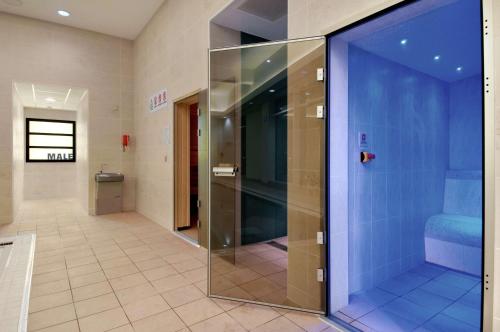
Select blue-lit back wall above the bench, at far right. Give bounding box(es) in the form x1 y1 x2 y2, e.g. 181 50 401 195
450 75 483 170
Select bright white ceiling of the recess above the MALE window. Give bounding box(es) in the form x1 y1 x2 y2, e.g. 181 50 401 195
14 83 87 111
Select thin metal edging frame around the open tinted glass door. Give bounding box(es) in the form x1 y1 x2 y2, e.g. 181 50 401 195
207 36 330 316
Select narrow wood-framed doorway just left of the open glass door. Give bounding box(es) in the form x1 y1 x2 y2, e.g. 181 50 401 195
174 94 200 244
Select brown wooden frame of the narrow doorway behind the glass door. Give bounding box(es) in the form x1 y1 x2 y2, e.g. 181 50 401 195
173 92 199 242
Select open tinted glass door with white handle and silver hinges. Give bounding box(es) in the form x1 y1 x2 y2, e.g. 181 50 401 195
209 38 326 313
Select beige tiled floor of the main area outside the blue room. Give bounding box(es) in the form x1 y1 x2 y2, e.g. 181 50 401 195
0 200 334 332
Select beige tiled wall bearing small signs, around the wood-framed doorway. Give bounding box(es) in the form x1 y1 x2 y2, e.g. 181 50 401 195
134 0 229 229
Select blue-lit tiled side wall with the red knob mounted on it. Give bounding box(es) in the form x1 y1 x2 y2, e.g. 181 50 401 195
348 46 449 292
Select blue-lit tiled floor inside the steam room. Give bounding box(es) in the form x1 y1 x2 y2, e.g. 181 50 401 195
336 264 481 332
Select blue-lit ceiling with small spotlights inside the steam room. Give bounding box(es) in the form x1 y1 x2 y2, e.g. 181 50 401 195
340 0 482 82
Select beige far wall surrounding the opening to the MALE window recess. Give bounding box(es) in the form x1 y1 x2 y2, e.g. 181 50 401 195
0 13 134 223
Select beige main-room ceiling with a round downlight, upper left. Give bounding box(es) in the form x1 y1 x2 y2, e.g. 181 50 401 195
0 0 164 40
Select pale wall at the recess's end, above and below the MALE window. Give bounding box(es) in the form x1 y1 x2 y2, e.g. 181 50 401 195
22 107 76 200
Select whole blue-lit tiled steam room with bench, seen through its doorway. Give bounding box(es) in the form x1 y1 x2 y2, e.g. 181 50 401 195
328 0 483 332
